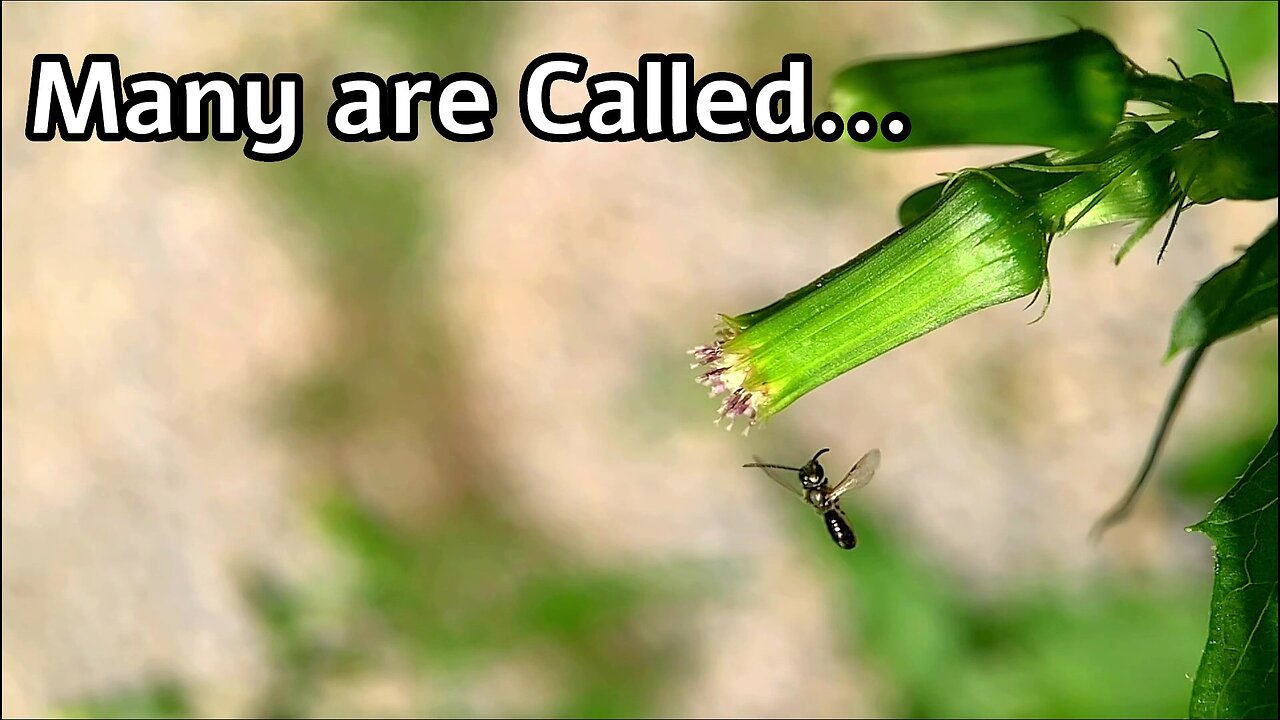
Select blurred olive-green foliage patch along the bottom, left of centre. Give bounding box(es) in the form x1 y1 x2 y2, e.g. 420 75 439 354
234 496 681 717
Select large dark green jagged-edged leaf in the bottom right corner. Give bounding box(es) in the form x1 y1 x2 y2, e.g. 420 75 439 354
1190 430 1277 717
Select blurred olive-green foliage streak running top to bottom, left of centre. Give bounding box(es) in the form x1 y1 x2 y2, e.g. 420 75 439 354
257 4 678 716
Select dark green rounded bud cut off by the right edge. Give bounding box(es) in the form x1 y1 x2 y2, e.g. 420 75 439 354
1174 102 1276 205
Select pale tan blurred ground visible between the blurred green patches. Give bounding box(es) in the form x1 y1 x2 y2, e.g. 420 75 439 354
0 4 1276 716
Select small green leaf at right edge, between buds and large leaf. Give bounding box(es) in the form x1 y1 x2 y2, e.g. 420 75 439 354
1166 224 1276 357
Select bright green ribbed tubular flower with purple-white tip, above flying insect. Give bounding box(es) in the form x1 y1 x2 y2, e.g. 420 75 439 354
690 170 1050 428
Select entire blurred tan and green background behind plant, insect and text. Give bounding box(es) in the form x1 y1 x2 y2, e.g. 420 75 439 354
3 3 1276 717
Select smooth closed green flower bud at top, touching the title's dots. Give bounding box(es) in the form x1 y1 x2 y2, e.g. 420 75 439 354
831 29 1129 150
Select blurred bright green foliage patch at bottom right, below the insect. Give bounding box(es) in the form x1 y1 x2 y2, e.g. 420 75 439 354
819 503 1207 717
